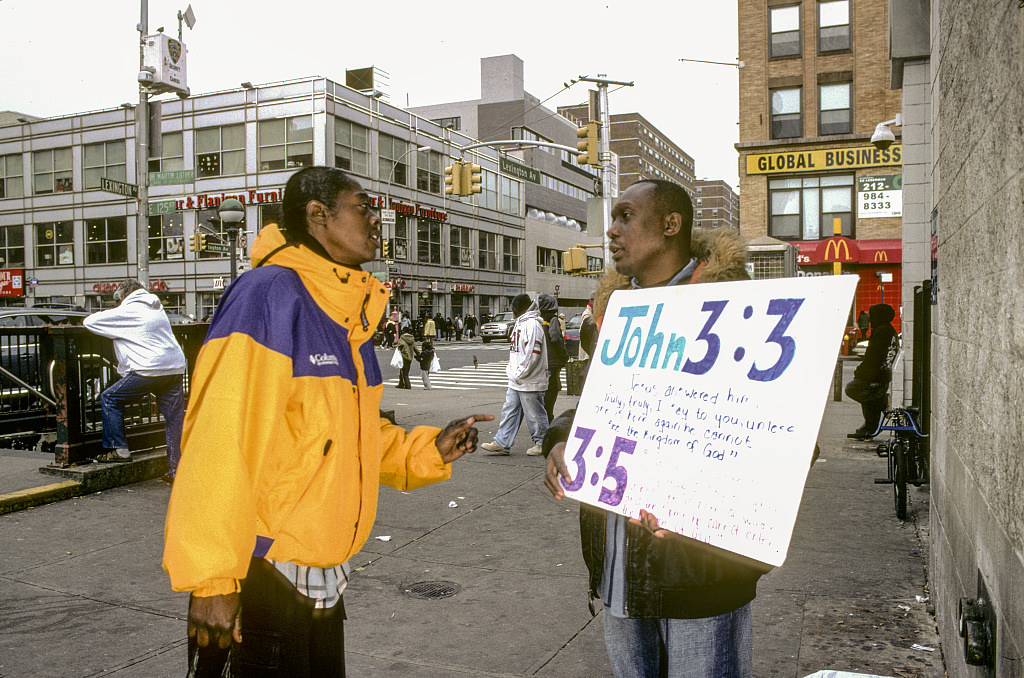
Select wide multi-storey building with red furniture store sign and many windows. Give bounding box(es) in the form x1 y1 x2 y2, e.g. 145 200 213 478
0 78 527 317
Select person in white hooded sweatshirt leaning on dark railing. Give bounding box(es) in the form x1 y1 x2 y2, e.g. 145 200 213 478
84 279 185 483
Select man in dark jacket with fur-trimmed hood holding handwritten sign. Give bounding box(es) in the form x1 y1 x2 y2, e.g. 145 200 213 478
544 180 768 678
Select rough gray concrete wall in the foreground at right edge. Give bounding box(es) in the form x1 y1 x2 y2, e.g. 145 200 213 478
930 0 1024 678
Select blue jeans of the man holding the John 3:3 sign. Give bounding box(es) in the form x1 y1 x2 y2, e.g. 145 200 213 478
604 603 754 678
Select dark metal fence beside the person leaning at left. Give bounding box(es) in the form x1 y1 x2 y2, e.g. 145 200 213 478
0 324 209 466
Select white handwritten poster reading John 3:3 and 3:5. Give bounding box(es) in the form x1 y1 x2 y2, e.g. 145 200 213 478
562 276 857 565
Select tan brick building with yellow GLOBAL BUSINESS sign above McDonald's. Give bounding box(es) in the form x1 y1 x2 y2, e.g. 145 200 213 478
736 0 903 329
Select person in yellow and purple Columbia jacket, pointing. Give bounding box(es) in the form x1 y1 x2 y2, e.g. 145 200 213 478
164 167 493 676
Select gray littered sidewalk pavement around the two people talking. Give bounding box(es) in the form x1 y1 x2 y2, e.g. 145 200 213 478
0 367 943 678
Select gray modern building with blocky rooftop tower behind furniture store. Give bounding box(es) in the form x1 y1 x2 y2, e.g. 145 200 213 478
410 54 603 316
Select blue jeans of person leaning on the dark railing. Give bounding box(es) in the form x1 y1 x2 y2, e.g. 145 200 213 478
99 372 185 477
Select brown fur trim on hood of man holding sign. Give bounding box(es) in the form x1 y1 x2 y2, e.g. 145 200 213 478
594 228 750 317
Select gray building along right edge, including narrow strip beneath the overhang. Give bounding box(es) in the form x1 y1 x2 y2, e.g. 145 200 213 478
889 0 1024 678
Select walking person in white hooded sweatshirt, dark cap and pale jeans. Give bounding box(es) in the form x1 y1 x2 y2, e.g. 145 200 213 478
480 294 548 457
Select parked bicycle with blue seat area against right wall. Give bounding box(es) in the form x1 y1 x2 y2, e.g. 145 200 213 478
871 407 929 520
